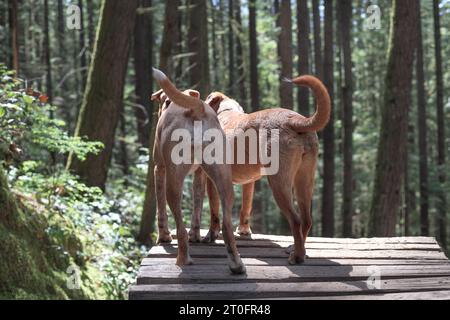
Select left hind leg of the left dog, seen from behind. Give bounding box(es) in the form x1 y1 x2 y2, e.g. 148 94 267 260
166 168 192 266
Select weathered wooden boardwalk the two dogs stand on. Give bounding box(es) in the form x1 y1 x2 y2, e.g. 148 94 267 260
129 230 450 300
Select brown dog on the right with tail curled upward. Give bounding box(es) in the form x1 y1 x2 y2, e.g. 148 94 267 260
197 76 331 264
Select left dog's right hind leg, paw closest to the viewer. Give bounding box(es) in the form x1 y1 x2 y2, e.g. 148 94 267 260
204 165 246 274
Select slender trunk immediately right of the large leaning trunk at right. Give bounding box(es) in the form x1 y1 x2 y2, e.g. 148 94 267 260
416 3 430 236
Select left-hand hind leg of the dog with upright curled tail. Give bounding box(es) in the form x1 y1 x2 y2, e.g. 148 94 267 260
269 175 306 264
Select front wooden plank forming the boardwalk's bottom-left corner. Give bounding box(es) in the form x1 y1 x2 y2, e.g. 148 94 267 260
129 277 450 300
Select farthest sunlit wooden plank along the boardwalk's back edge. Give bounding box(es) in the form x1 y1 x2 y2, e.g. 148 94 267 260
171 228 437 244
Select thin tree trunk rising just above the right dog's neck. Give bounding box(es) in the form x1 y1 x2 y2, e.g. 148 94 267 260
235 0 248 106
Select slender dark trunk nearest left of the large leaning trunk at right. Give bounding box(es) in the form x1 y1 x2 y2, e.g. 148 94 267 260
338 0 353 237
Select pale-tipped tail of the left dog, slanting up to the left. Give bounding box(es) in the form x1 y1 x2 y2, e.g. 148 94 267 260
153 68 205 116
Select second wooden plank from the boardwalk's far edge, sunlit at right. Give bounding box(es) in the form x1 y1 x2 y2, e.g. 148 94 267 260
164 240 441 251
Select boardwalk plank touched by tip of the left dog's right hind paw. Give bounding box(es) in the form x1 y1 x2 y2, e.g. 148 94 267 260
137 265 450 284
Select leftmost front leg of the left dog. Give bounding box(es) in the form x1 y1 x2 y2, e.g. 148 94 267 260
154 165 172 243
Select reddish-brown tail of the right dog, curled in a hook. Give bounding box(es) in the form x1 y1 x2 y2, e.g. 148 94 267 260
290 76 331 133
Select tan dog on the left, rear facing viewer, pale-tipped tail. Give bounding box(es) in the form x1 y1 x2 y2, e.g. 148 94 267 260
152 69 245 274
